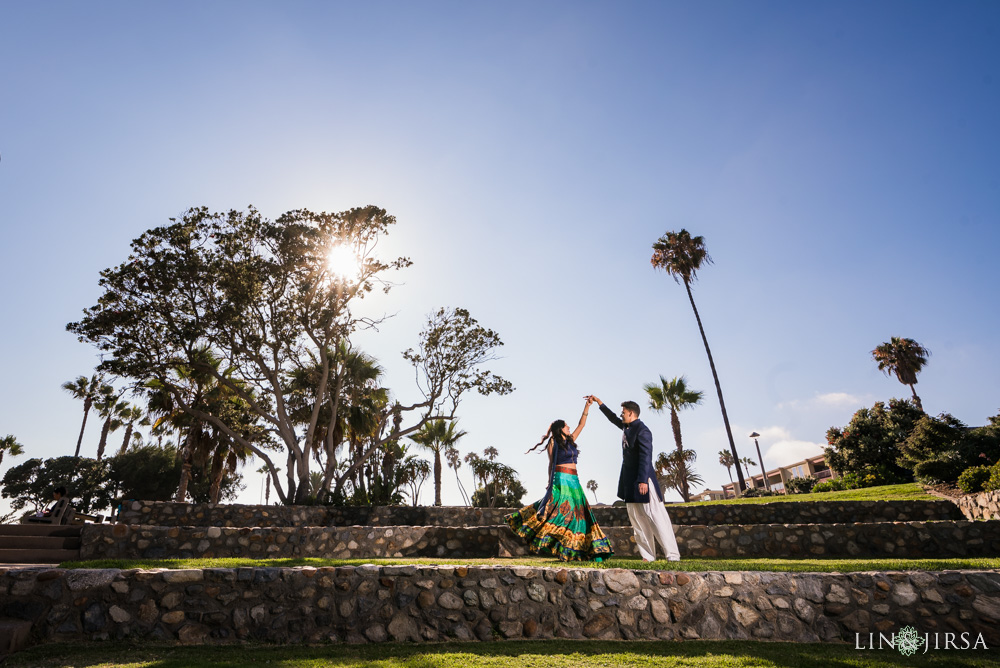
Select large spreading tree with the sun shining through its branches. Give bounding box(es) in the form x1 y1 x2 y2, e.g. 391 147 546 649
67 206 513 503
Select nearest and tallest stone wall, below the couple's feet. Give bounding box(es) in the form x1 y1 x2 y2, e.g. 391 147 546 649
0 566 1000 648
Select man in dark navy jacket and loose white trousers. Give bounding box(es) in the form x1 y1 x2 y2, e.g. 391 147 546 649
590 395 681 561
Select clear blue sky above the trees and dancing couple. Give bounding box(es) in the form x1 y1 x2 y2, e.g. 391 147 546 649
0 2 1000 503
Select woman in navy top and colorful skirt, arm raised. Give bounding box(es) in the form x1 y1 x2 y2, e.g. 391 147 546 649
505 397 614 562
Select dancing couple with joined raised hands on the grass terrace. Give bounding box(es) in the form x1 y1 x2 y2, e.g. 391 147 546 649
506 394 680 562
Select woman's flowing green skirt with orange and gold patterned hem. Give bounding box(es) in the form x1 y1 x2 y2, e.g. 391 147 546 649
504 466 614 561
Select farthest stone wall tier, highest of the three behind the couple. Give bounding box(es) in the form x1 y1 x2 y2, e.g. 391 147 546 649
113 501 964 527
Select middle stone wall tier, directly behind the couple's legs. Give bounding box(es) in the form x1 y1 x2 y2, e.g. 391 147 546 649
80 521 1000 560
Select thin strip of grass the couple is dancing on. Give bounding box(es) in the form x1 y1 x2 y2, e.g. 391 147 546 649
59 557 1000 573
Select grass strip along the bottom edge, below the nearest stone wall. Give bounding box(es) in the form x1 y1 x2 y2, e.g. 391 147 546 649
4 640 1000 668
